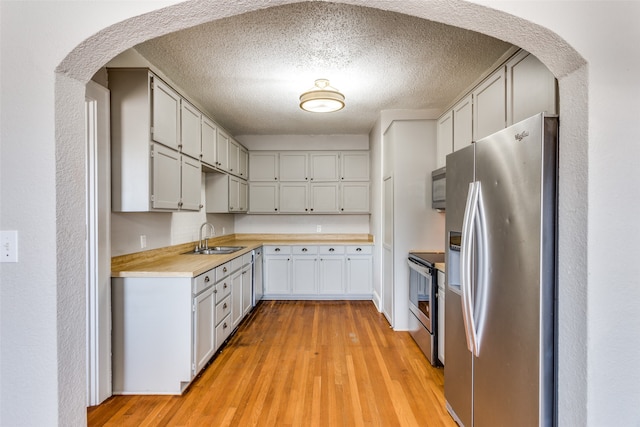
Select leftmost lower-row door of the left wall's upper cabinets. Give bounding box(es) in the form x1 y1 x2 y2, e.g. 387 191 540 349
151 144 181 209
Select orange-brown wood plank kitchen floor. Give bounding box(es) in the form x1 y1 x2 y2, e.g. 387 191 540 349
87 301 456 427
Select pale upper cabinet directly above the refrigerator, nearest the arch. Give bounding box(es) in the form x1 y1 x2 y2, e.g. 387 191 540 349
507 51 557 126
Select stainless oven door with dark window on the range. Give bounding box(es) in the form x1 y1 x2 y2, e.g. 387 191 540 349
408 259 435 335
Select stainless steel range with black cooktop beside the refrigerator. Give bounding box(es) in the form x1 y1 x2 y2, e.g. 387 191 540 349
407 252 444 365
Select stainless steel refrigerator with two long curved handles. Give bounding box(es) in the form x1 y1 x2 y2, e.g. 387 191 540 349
444 114 558 427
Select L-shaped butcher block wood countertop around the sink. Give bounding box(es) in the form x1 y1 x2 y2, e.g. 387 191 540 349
111 234 373 277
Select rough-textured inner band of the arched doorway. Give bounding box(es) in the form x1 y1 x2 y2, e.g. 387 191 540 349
56 0 587 426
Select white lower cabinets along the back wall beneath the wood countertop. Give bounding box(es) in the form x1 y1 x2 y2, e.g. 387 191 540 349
263 244 373 300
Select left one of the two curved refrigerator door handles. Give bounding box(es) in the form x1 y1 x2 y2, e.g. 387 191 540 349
460 182 478 355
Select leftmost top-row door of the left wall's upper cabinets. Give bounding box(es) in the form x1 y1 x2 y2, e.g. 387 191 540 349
151 76 180 150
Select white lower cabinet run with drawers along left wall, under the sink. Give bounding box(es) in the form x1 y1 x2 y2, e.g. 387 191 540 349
111 253 252 394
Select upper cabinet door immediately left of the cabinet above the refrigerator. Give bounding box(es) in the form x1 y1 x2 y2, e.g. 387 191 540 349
472 67 507 141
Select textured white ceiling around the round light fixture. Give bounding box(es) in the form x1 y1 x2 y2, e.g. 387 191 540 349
136 2 511 135
